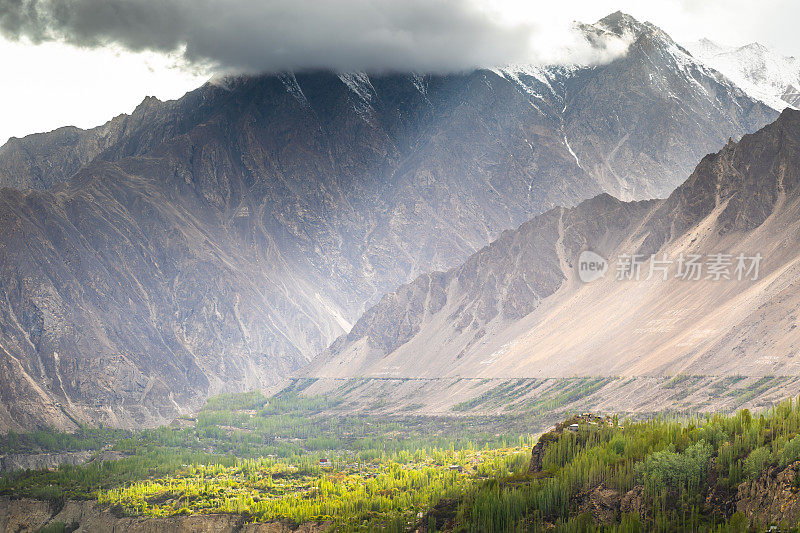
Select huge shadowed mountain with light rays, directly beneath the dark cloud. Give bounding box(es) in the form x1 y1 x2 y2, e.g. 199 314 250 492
0 14 774 427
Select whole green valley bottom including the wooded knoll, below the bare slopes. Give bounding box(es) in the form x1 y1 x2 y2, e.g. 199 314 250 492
0 382 800 532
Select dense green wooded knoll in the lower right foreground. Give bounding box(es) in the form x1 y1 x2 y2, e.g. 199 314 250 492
450 394 800 532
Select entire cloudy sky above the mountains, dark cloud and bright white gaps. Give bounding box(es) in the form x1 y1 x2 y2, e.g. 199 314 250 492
0 0 800 144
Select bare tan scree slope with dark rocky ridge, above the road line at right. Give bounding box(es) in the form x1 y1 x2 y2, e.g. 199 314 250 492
305 109 800 377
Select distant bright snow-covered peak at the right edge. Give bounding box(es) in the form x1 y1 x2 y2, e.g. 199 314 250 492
687 39 800 111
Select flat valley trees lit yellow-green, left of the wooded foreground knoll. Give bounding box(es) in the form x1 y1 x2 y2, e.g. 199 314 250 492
0 384 533 530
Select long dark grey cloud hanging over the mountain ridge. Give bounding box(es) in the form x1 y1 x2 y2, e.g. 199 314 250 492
0 0 628 71
